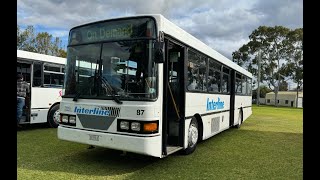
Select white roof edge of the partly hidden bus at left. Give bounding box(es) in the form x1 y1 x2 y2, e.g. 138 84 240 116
17 50 66 64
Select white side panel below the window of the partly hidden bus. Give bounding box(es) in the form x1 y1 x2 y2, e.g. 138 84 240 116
31 87 62 109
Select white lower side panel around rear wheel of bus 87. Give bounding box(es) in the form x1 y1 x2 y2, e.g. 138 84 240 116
233 95 252 125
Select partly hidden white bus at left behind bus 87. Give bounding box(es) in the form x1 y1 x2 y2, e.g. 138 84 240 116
17 50 66 128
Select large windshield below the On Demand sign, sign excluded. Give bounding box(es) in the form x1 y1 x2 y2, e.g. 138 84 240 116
64 40 157 100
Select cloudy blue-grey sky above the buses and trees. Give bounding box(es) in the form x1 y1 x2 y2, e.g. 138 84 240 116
17 0 303 88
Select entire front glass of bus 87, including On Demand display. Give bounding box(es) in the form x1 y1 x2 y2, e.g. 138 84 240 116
64 17 158 100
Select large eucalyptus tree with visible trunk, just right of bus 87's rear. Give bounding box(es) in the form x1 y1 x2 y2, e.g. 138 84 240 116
232 26 290 106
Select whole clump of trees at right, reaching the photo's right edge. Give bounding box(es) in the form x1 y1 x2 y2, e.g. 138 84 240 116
232 26 303 106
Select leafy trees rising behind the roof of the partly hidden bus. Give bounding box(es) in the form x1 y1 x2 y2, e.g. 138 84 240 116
17 25 67 58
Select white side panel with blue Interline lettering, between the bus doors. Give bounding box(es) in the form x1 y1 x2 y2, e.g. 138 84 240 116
185 93 230 142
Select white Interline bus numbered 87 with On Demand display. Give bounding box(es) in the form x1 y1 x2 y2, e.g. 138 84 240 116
58 15 252 158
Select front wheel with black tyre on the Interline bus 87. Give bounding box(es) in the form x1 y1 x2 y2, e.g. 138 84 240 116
183 117 199 154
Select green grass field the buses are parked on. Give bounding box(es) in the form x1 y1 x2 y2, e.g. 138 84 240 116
17 106 303 180
